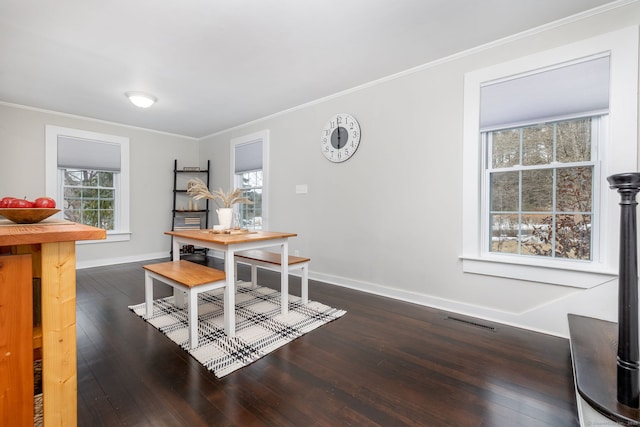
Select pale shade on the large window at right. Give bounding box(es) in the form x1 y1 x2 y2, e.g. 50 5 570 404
480 56 609 131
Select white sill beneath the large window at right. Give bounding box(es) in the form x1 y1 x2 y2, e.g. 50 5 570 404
460 256 618 289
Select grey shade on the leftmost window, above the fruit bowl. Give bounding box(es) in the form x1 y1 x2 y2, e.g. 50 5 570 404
58 136 120 171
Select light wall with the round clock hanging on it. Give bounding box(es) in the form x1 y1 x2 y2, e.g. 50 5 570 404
200 2 640 336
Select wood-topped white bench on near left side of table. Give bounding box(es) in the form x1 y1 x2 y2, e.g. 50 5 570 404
142 260 227 349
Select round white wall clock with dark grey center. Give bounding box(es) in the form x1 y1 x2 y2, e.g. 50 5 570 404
320 113 360 163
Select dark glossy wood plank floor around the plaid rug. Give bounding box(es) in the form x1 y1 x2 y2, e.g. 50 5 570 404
77 262 578 427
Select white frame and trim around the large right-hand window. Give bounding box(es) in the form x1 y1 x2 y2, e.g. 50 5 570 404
460 27 638 288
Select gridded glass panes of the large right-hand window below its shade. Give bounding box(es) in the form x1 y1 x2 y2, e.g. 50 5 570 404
483 117 600 261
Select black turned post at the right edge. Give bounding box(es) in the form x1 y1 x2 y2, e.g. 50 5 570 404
607 173 640 408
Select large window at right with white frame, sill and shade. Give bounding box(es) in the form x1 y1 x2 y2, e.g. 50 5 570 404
461 27 638 288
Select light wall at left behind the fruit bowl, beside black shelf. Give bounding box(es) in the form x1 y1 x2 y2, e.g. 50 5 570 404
0 104 200 267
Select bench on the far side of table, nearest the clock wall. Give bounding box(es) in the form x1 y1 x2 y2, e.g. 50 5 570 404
234 249 311 304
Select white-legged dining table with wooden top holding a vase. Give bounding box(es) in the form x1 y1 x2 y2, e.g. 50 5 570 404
165 229 297 337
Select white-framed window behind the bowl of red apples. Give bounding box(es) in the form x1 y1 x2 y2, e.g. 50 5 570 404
46 126 130 241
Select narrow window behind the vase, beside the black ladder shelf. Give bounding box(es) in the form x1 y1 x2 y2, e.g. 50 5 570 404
231 131 269 230
